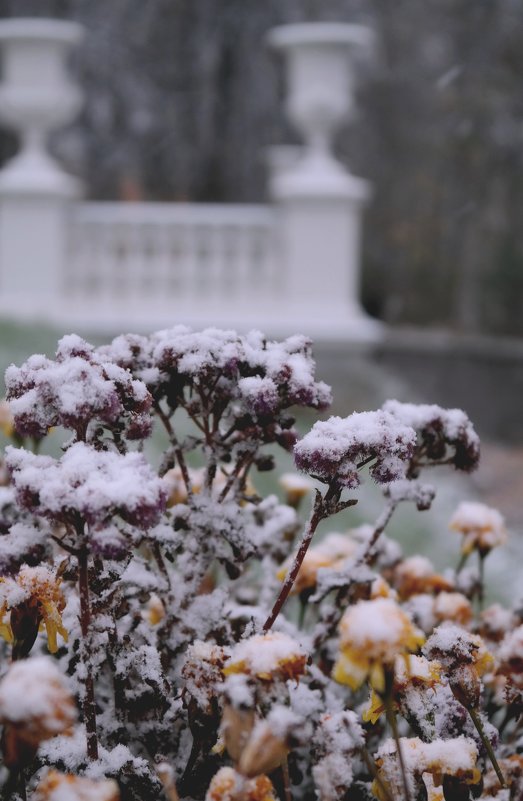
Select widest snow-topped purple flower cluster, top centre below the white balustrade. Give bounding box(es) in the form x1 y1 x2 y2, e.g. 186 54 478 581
98 326 331 458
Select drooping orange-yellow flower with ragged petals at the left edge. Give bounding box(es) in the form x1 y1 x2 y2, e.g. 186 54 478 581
0 565 67 657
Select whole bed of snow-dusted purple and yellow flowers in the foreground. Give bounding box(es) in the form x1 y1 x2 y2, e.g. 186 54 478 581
0 326 523 801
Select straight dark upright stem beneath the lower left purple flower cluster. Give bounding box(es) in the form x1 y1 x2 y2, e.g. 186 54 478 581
78 545 98 761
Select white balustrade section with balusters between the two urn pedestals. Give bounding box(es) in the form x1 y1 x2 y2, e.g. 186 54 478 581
61 203 283 327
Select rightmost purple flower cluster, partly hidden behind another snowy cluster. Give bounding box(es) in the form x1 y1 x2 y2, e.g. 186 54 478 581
383 400 480 472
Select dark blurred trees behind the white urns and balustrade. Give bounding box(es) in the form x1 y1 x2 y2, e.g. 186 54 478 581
0 0 523 335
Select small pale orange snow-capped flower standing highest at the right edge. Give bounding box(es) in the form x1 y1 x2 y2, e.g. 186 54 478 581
450 501 507 556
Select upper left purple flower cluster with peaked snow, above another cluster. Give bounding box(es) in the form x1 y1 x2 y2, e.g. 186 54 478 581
5 334 152 440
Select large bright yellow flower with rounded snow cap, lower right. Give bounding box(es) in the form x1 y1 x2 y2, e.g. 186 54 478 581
333 598 425 693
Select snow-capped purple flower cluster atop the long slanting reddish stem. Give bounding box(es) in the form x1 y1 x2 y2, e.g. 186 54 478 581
294 411 416 489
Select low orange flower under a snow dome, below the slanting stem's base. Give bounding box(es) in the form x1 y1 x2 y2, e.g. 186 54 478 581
223 632 307 681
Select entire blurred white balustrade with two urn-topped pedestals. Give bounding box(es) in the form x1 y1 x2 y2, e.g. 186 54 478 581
0 19 380 339
